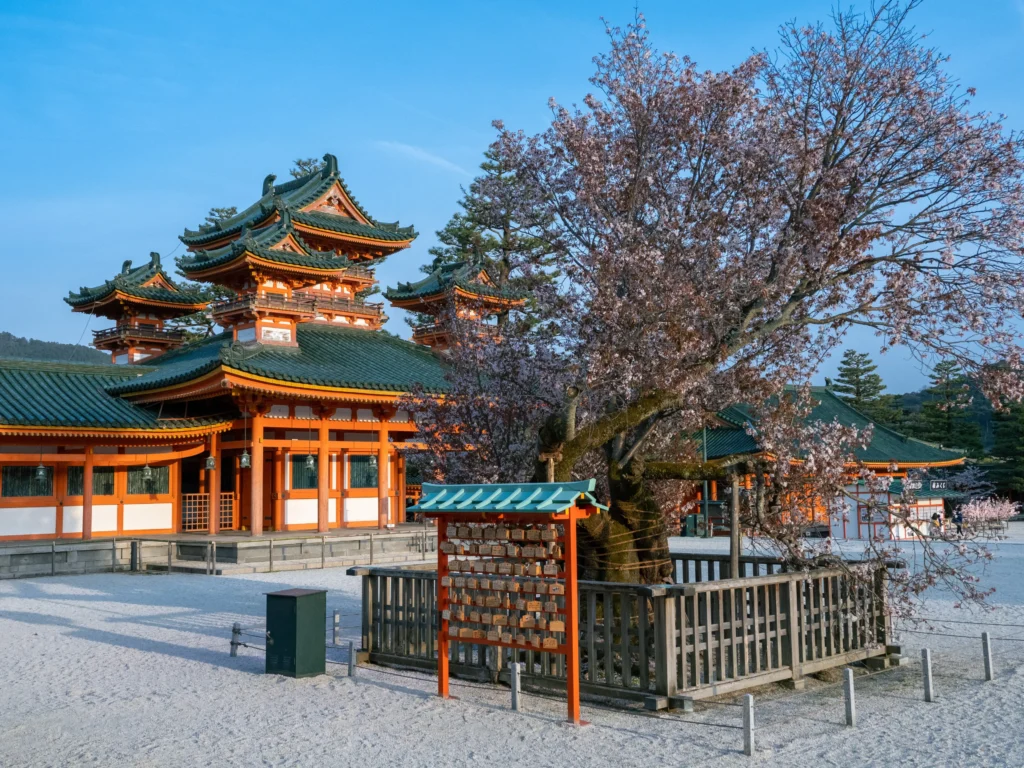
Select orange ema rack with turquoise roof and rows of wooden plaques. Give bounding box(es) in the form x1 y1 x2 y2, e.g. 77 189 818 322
410 480 606 724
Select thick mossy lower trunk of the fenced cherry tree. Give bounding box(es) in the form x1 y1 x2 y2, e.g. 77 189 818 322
580 456 672 584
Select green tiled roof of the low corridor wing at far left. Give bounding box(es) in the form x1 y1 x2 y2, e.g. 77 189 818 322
0 360 218 429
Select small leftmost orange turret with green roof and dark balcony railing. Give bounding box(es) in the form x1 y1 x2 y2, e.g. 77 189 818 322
65 253 207 364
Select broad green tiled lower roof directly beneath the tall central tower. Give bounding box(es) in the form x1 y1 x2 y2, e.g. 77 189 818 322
111 323 447 393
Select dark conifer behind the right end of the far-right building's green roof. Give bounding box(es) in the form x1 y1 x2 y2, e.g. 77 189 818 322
916 360 982 457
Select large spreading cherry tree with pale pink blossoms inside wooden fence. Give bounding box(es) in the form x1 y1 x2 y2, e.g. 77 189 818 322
409 1 1024 582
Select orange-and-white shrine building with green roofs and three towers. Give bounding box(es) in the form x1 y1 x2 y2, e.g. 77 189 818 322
0 155 507 540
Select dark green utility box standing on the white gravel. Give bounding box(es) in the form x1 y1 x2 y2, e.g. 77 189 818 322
266 590 327 677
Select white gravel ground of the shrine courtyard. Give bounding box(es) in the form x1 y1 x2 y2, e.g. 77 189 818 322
0 523 1024 768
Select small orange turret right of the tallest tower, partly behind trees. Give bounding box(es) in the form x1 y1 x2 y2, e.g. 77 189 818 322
384 261 524 351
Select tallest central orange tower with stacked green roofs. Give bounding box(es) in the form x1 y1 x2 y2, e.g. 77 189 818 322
179 155 416 346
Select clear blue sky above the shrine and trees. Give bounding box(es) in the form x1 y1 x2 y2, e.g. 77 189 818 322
0 0 1024 391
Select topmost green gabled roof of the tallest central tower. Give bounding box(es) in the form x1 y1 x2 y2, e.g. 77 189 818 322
180 155 416 248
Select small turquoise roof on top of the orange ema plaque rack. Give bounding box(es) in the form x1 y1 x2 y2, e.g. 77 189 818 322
410 480 607 514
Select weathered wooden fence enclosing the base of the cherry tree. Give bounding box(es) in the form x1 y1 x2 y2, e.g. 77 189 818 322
350 555 890 708
